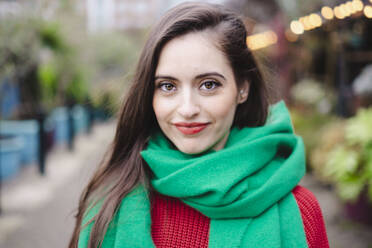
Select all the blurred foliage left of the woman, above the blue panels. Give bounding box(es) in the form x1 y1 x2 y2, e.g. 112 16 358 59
0 5 144 118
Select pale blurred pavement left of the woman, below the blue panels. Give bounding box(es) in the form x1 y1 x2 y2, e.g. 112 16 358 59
0 122 115 248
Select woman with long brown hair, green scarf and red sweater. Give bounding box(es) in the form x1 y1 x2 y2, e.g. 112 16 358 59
70 3 328 247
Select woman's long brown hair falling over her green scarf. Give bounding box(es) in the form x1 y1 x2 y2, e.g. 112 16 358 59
69 3 269 248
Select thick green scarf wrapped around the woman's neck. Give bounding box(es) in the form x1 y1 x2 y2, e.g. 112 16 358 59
79 102 307 248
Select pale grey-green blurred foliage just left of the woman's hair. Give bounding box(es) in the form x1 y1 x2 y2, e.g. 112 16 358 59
84 31 144 116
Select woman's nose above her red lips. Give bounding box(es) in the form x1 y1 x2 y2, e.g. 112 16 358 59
178 91 200 119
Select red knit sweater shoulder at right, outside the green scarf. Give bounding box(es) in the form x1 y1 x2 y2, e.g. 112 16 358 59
292 185 329 248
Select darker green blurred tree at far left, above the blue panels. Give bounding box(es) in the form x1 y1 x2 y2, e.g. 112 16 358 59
0 15 88 116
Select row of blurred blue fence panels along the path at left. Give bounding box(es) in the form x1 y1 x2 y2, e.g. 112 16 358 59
0 105 89 180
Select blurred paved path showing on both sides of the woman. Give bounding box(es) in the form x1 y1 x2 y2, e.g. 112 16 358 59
0 120 372 248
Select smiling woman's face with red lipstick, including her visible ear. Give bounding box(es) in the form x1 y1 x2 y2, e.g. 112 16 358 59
153 32 248 154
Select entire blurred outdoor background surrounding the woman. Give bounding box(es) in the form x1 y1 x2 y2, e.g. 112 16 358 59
0 0 372 248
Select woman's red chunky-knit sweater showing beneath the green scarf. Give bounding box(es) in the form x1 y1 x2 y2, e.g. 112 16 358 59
151 186 329 248
